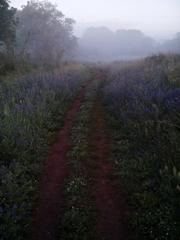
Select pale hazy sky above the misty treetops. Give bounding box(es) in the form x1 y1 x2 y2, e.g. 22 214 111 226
11 0 180 38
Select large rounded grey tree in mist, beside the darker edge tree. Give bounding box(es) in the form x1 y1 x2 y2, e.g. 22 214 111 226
17 1 76 65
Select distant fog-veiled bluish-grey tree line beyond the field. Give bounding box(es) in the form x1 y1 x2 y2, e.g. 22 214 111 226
76 27 180 61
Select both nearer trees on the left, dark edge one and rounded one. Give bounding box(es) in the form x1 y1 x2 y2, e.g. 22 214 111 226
0 0 77 73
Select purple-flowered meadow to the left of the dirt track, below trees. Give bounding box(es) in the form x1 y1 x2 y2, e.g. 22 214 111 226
0 66 89 240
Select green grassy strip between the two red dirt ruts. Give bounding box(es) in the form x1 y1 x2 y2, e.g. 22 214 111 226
60 79 99 240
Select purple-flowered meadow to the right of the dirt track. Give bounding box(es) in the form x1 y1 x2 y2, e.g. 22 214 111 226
104 55 180 240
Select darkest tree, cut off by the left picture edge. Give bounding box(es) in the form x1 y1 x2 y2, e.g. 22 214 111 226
0 0 16 51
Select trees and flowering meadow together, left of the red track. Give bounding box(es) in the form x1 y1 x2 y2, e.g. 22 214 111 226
0 0 89 240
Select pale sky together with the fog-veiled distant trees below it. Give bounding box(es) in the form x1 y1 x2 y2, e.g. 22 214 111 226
8 0 180 61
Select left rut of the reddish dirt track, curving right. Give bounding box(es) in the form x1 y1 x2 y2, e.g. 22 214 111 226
32 82 89 240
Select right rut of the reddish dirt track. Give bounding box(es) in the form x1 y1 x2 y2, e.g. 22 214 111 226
90 99 130 240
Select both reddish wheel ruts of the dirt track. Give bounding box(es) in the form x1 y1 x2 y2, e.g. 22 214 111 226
32 75 130 240
